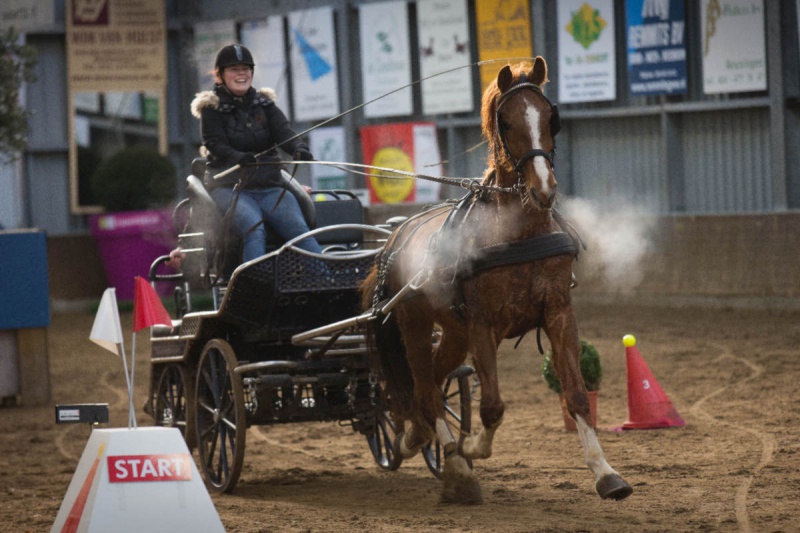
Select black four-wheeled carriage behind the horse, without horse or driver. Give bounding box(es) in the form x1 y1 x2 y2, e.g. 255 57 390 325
146 162 472 492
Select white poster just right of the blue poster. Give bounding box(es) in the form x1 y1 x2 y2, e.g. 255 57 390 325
700 0 767 94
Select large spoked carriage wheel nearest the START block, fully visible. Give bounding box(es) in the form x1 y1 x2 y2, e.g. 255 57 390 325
195 339 247 492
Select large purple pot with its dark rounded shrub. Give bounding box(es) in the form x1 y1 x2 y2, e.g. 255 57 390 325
89 146 177 300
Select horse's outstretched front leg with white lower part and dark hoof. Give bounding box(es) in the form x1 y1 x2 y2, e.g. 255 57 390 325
546 307 633 500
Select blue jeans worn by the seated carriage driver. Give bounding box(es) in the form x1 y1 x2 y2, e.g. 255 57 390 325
211 187 322 261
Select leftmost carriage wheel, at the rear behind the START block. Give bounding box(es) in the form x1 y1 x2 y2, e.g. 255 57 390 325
154 364 196 450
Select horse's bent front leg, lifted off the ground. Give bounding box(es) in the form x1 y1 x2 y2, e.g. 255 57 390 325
461 330 505 459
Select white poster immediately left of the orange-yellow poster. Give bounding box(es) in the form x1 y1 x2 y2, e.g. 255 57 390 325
417 0 474 115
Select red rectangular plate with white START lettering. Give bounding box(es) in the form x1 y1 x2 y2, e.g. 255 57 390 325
107 453 192 483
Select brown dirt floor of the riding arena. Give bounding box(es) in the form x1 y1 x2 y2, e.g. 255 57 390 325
0 302 800 533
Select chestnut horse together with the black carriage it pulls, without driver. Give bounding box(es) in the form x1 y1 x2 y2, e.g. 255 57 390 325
149 56 633 503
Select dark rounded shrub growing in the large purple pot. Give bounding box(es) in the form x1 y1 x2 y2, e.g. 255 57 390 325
91 146 178 211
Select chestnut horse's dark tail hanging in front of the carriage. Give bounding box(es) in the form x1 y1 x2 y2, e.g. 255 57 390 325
361 268 414 418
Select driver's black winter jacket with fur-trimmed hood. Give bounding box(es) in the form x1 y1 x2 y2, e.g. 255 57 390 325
191 85 308 189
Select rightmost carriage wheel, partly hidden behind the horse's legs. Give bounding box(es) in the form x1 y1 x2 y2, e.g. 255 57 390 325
422 365 474 478
